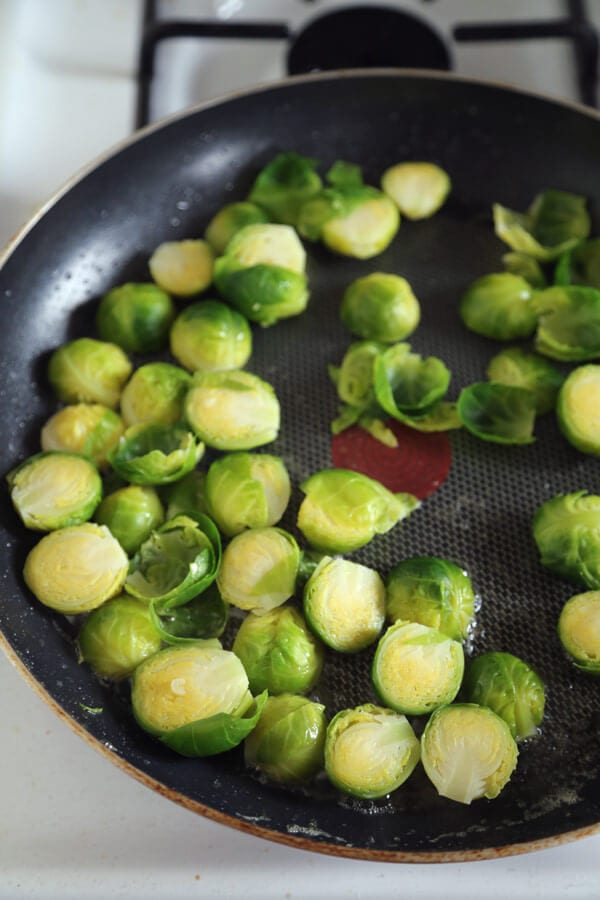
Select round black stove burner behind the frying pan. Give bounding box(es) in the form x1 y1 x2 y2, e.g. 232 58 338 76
287 6 451 75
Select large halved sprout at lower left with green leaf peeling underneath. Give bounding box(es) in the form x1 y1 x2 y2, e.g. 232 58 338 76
131 642 267 756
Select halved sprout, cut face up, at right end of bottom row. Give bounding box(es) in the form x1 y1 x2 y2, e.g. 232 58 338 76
421 703 519 804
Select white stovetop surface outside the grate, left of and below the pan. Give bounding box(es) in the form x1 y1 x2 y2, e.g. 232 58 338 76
0 0 600 900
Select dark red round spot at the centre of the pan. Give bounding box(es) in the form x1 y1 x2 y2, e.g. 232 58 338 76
331 419 452 500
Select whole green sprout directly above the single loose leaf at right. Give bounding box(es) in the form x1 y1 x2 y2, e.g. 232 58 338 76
487 347 564 416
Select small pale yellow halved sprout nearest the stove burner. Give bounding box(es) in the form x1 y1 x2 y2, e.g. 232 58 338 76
381 161 452 220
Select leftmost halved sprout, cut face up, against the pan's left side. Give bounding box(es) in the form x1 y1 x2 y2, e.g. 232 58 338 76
6 450 102 531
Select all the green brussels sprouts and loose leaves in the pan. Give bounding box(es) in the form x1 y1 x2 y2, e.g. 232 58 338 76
8 153 600 803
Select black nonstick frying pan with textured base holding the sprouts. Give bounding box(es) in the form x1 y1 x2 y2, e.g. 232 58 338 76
0 70 600 862
